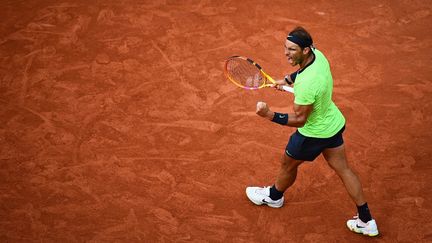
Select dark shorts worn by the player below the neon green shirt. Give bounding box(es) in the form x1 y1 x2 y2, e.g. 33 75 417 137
285 126 345 161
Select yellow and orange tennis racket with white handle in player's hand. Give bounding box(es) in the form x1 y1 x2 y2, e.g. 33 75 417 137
225 56 294 93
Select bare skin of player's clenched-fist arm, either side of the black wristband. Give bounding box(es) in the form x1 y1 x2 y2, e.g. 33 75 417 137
256 102 313 127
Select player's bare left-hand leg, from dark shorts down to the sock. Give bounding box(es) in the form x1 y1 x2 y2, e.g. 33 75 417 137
275 154 303 192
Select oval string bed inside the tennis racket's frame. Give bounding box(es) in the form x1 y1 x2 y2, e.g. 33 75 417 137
227 58 265 89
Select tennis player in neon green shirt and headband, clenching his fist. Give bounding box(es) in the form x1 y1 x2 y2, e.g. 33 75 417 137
246 27 379 236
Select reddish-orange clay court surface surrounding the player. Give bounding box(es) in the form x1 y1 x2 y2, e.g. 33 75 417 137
0 0 432 242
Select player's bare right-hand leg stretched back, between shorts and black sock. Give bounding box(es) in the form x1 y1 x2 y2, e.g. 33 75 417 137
323 145 366 206
